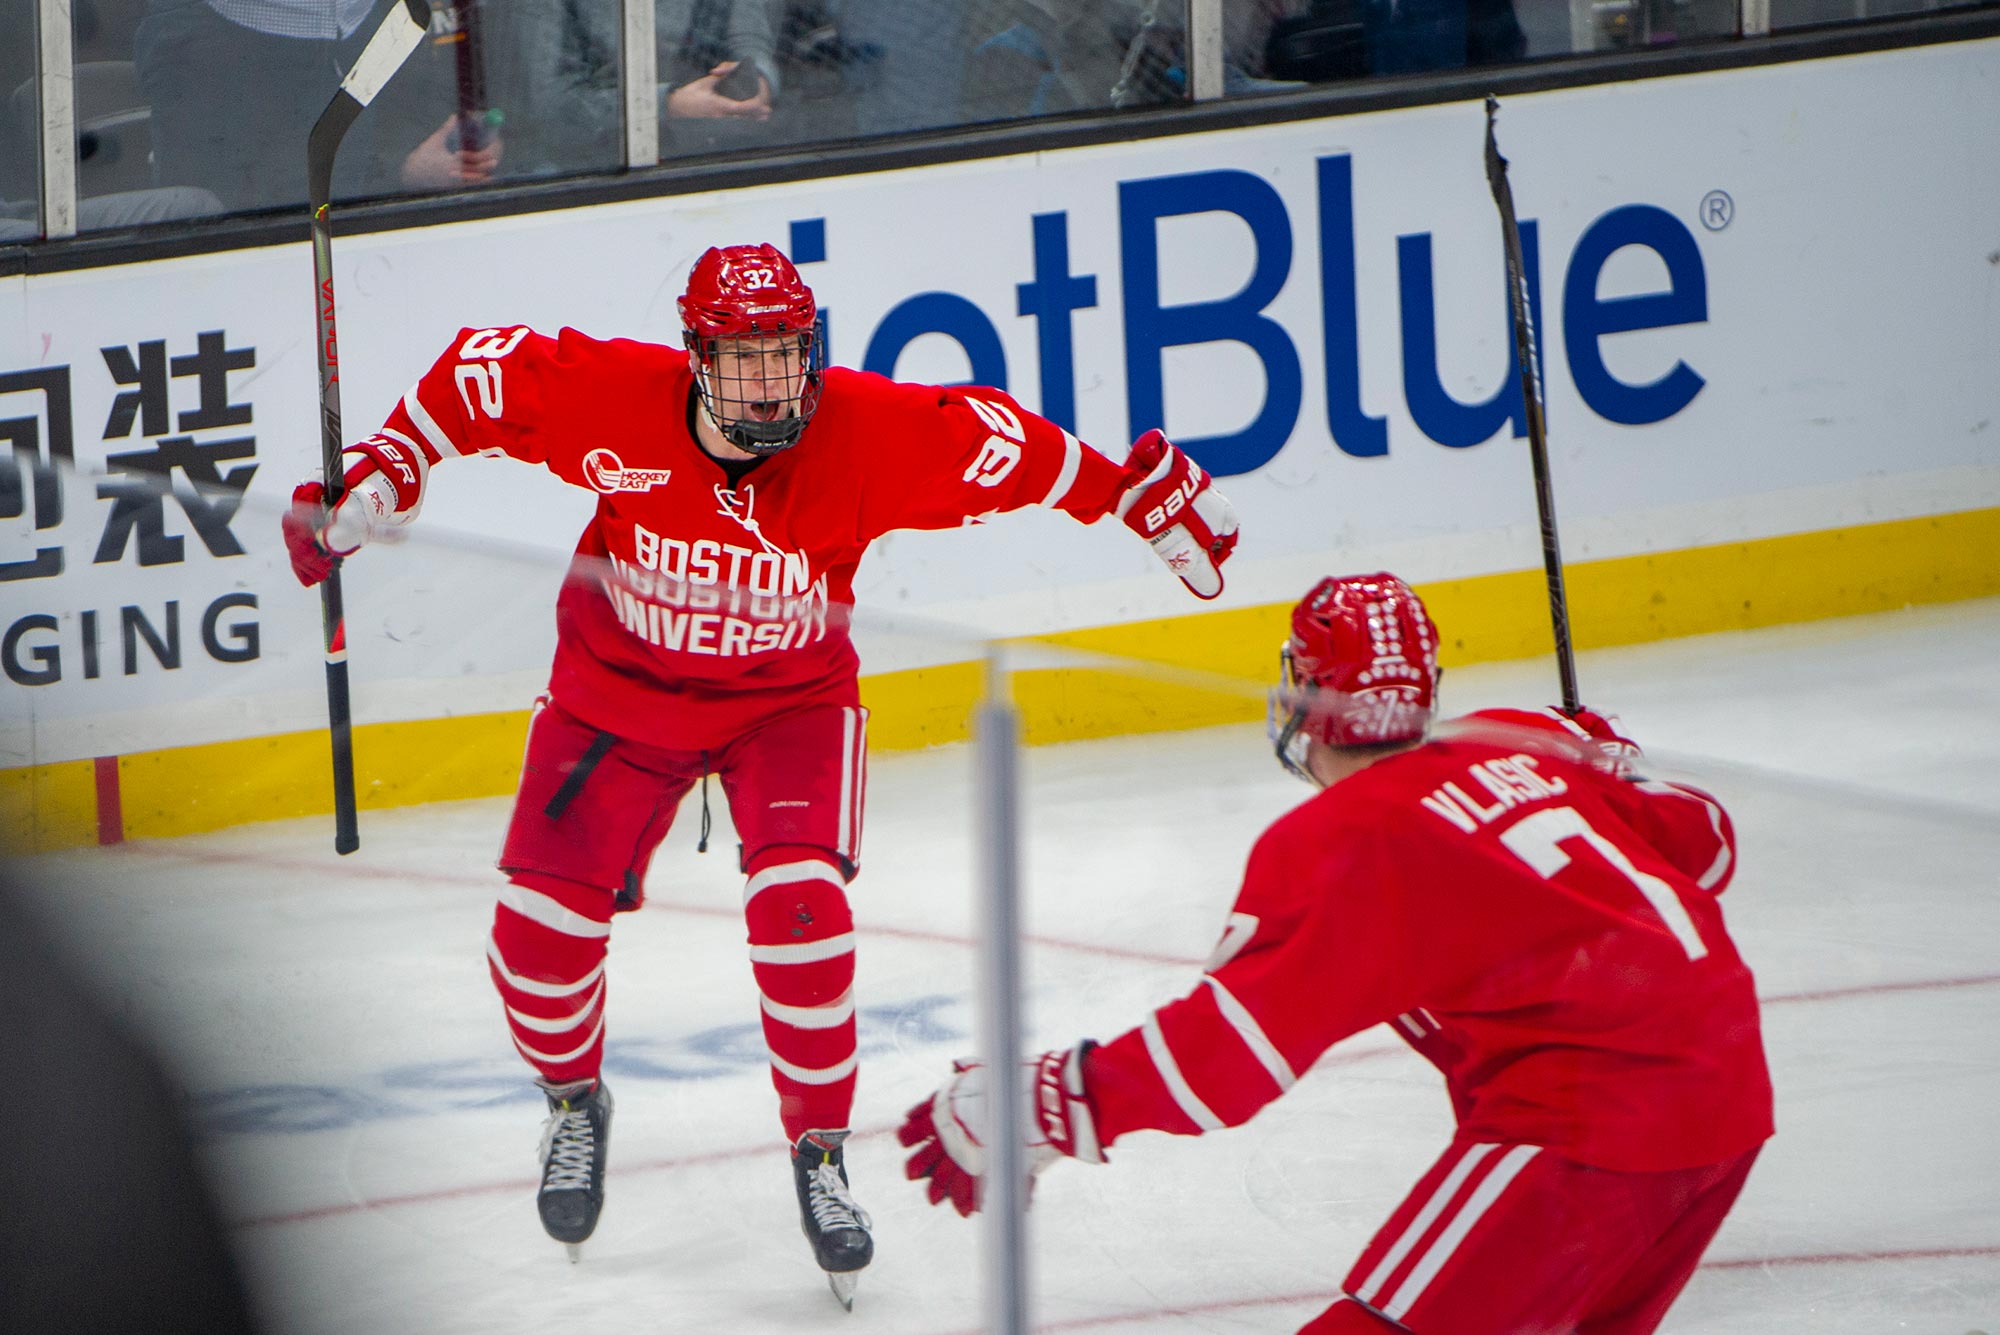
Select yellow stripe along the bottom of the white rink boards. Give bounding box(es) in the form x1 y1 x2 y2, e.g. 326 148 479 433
0 499 2000 853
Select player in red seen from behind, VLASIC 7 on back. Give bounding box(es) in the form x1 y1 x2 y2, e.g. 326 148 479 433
902 574 1772 1335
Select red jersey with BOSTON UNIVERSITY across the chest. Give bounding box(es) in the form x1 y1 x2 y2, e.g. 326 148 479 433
364 328 1124 749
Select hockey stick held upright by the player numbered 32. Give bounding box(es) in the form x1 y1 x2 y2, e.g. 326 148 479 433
306 0 430 853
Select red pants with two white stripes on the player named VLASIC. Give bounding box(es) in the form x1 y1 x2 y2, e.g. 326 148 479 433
1300 1141 1758 1335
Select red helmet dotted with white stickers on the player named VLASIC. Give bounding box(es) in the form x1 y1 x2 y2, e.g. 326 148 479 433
1270 572 1438 777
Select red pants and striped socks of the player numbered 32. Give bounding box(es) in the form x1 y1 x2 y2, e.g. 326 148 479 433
486 701 868 1141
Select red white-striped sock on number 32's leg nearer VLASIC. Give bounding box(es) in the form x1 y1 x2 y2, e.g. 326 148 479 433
744 845 856 1143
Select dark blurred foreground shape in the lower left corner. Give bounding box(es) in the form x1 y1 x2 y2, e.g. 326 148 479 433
0 883 256 1335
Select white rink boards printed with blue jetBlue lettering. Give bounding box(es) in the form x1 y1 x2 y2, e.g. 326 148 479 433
0 42 2000 767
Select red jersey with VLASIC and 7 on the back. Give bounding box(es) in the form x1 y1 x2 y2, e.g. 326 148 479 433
1084 711 1772 1171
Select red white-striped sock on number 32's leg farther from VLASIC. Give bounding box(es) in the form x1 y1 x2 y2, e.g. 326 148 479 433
486 871 612 1085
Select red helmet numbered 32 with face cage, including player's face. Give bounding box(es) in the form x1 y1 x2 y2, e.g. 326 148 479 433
680 246 820 454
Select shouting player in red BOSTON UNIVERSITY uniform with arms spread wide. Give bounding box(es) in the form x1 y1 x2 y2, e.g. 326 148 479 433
284 246 1236 1301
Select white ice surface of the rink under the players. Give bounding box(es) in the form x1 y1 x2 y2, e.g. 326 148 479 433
16 602 2000 1335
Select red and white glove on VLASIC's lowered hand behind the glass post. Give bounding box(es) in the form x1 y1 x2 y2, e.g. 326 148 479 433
896 1043 1104 1215
